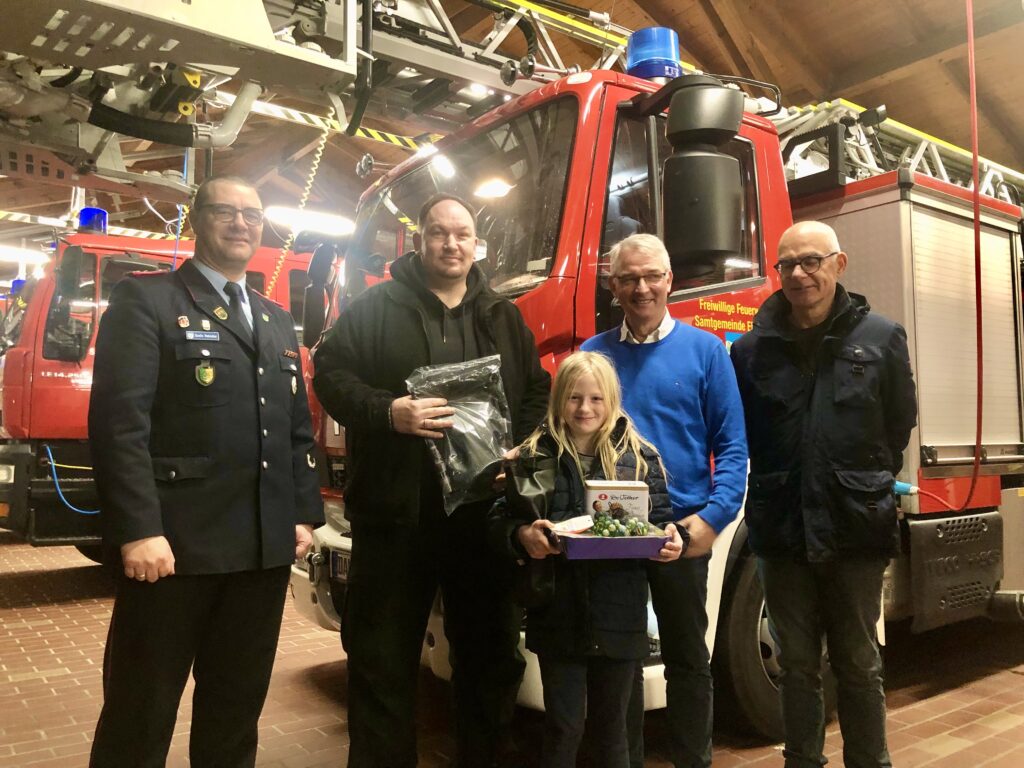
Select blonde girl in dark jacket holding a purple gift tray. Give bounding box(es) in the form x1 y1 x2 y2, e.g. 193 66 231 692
493 352 682 768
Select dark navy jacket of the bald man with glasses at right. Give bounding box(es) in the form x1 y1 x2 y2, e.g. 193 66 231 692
731 286 918 562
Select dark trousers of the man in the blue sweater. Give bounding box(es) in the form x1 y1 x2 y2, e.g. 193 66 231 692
628 555 714 768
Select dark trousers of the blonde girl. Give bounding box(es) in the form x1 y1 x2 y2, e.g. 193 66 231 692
540 654 636 768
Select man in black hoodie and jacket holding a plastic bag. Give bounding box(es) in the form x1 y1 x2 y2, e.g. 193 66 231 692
313 195 550 768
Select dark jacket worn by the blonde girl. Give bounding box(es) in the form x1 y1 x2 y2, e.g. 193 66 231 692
490 428 672 658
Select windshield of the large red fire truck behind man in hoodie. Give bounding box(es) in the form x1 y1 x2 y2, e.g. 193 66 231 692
346 97 577 296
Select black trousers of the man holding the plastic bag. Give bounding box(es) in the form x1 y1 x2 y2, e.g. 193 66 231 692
341 508 525 768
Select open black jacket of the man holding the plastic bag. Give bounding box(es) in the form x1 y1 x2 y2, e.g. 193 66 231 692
313 255 551 525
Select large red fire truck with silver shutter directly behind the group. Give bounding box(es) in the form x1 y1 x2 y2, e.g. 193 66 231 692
292 71 1024 736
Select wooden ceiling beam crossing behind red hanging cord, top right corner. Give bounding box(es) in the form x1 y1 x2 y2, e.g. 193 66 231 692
828 0 1024 97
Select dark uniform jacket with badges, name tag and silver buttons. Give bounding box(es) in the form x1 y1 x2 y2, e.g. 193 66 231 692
89 261 324 573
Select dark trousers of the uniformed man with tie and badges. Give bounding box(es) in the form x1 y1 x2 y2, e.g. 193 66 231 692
89 565 289 768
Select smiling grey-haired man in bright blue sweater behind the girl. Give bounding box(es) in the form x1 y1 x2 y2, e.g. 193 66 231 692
583 234 746 768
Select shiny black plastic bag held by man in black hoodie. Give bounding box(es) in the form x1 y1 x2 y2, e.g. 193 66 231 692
406 354 512 515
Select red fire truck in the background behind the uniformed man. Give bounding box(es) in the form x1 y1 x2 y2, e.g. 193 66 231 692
0 233 308 558
